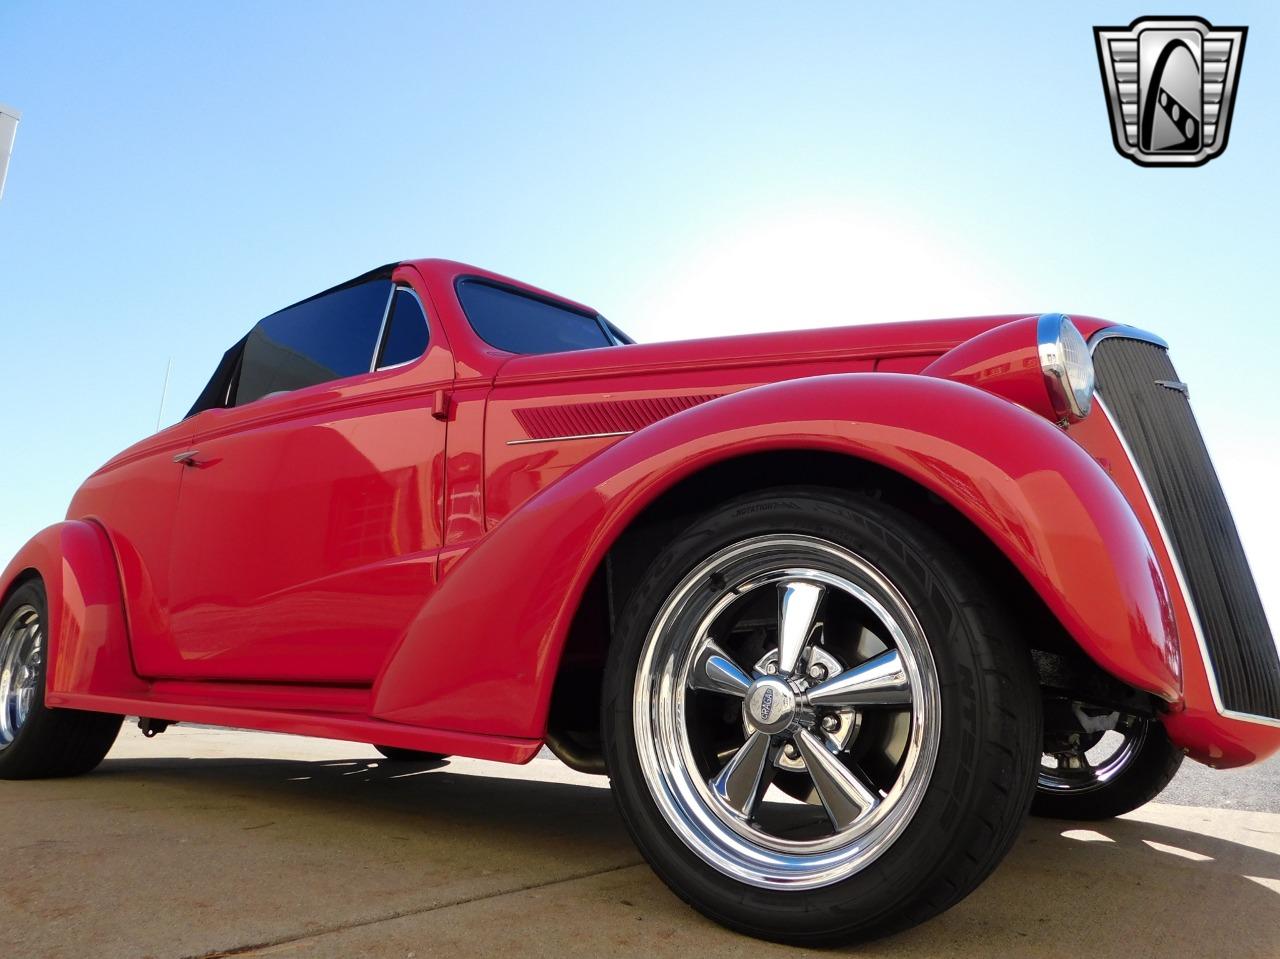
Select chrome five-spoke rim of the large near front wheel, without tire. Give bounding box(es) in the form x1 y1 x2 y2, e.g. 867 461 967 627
634 534 941 889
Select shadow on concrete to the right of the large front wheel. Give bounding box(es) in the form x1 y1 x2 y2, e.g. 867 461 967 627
875 810 1280 959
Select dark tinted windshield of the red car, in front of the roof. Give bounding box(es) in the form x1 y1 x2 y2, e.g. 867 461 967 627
457 279 614 353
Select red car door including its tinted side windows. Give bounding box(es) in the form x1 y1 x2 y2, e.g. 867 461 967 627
142 271 453 685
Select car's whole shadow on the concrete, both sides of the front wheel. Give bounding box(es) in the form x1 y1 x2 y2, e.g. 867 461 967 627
83 757 1280 959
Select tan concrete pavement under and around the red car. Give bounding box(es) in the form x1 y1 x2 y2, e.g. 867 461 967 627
0 727 1280 959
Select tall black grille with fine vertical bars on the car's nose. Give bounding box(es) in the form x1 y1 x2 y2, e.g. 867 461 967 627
1093 338 1280 720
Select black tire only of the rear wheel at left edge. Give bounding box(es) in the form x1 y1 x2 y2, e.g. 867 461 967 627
0 580 124 780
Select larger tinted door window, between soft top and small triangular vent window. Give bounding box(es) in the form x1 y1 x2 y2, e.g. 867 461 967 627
234 279 392 406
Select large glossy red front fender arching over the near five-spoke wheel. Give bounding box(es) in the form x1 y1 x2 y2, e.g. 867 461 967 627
374 374 1180 737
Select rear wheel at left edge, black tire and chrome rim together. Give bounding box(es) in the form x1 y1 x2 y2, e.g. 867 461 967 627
0 581 123 780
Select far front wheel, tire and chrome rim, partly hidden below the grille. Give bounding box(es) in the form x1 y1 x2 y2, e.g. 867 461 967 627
1032 716 1183 819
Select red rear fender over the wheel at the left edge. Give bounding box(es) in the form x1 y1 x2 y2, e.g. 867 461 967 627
0 520 146 705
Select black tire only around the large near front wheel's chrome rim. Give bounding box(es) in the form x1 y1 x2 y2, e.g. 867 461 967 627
602 488 1042 946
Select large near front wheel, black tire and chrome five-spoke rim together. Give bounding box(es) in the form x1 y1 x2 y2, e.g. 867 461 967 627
603 489 1041 945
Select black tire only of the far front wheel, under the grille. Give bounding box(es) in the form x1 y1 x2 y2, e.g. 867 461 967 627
1032 720 1183 821
